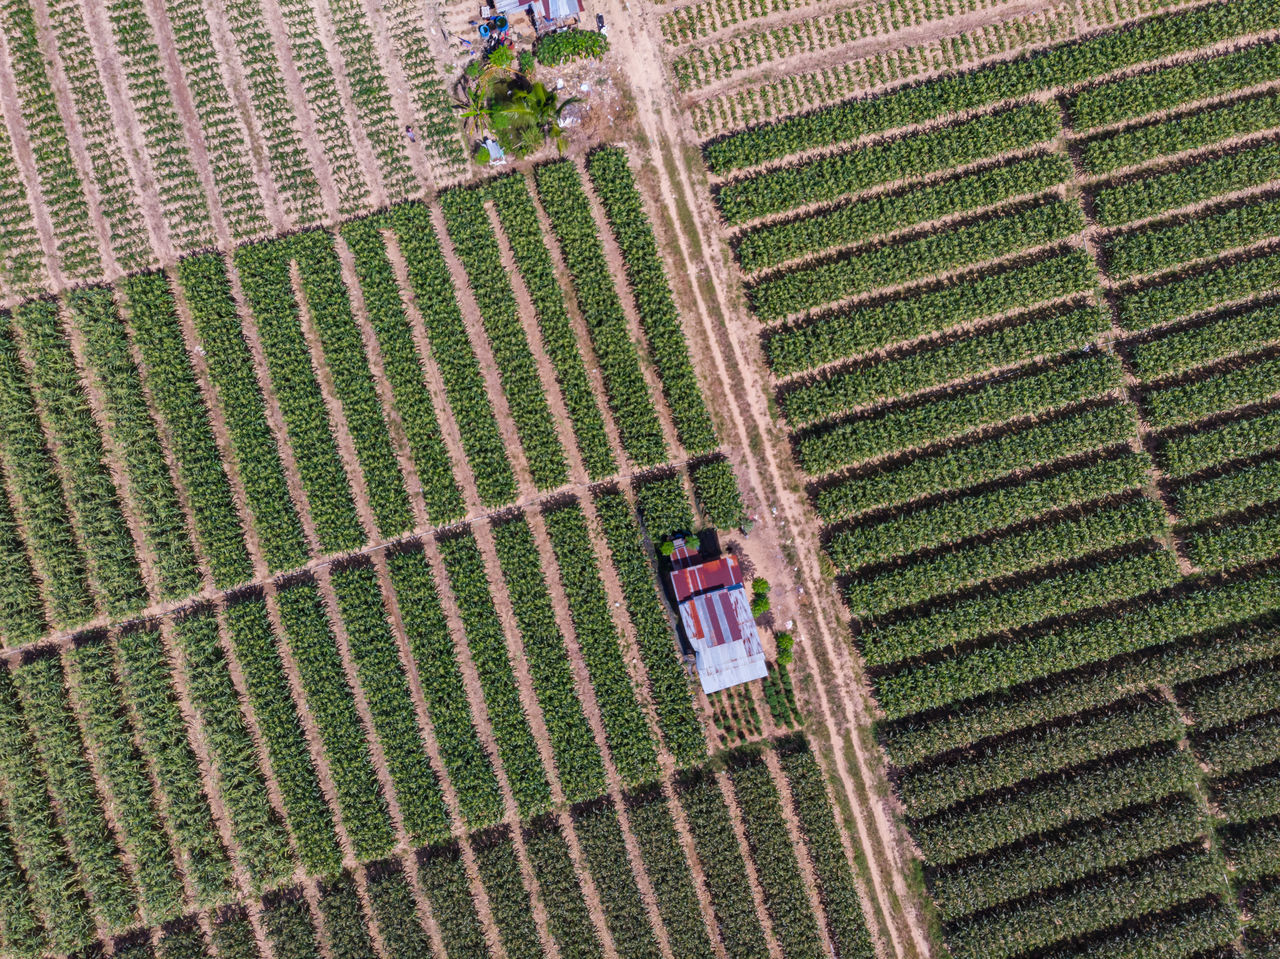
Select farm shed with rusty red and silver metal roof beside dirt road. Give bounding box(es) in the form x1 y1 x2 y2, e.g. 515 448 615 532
669 539 768 694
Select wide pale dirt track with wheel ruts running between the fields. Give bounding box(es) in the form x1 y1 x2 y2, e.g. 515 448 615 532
593 0 929 956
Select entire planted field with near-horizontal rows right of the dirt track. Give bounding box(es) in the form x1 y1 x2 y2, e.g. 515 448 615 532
686 0 1280 959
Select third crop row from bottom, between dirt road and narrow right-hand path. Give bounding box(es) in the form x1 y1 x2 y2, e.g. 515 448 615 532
928 793 1207 922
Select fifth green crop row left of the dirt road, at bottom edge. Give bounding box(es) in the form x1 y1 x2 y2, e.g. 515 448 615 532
573 798 662 959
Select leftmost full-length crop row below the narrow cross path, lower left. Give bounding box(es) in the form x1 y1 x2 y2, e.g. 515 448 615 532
13 656 138 932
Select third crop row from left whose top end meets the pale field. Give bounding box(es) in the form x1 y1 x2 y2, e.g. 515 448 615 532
122 273 252 589
